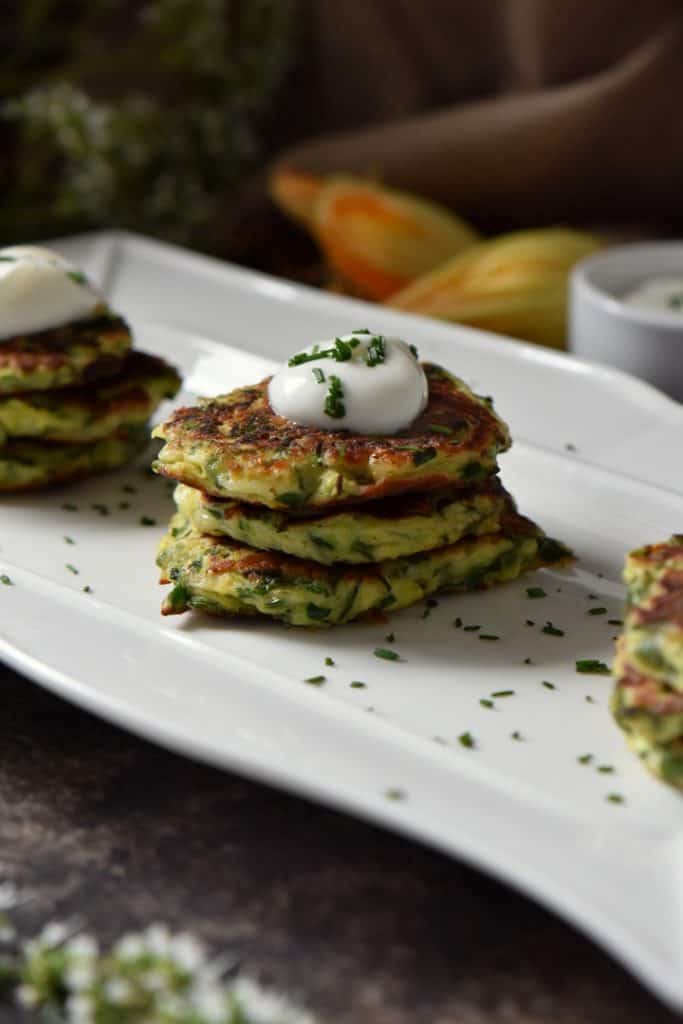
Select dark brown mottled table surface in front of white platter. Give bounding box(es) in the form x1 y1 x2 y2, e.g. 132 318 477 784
0 667 679 1024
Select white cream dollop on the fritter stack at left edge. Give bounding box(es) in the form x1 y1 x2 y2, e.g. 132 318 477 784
0 246 102 340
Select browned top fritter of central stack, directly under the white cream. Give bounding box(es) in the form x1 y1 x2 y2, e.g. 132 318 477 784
153 364 510 509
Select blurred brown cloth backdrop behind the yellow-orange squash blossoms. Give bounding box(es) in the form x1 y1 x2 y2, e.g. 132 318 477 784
275 0 683 234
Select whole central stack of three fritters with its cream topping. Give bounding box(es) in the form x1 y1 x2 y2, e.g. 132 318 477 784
155 331 569 627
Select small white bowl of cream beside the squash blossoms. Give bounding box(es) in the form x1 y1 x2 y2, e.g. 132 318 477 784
569 242 683 401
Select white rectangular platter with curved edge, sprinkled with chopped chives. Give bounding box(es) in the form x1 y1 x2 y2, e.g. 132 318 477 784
0 234 683 1009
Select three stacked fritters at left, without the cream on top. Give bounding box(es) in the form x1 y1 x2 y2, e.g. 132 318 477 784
0 305 180 492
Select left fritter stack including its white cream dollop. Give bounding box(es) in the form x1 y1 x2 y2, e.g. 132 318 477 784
0 246 180 492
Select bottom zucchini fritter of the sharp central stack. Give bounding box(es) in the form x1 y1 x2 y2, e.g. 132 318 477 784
157 510 570 627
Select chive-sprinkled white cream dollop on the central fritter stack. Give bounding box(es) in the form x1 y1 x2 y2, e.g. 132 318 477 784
268 330 429 434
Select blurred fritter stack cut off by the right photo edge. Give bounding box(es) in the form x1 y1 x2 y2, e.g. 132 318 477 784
611 534 683 790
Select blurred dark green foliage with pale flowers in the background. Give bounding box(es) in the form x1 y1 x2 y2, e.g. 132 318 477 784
0 0 294 248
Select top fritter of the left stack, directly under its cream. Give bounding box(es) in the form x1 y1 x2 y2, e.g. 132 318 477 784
0 311 131 394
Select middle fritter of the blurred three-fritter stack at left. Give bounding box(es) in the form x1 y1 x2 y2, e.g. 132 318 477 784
0 351 180 443
